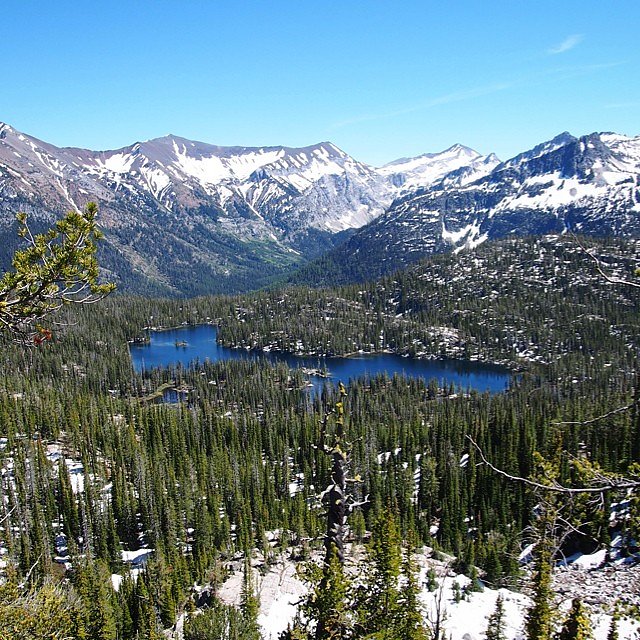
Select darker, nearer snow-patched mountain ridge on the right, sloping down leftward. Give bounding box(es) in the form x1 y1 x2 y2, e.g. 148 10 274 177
292 132 640 281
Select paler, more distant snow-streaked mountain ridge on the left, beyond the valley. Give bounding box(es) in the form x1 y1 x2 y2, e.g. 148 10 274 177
0 124 496 294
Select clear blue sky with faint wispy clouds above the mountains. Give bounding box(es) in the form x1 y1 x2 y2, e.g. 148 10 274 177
0 0 640 165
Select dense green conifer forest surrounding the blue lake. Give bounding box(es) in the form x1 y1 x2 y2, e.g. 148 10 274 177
0 238 640 640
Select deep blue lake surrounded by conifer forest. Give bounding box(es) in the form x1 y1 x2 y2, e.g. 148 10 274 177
130 325 512 393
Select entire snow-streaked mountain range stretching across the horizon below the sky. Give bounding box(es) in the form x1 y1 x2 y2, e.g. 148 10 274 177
0 124 640 295
